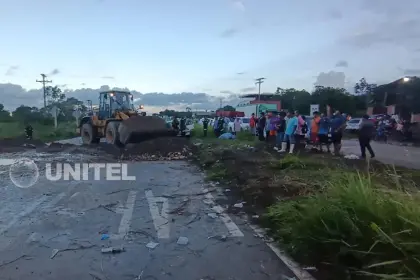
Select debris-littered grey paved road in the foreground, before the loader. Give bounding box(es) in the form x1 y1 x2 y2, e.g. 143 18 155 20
0 155 297 280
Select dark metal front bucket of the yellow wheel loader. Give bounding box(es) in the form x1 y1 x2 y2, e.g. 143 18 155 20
118 116 176 145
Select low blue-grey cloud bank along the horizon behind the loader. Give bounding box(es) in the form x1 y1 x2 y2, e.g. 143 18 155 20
0 84 243 111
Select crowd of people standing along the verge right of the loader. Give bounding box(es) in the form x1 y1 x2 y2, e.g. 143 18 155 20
203 107 375 158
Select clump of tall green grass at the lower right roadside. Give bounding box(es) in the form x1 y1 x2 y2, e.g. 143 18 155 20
267 174 420 279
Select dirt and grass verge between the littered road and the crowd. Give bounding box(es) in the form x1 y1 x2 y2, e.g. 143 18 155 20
193 139 420 279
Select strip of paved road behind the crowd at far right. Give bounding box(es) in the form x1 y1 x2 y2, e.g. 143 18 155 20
342 140 420 169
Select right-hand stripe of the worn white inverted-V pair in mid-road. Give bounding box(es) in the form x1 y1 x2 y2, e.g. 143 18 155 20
146 190 170 239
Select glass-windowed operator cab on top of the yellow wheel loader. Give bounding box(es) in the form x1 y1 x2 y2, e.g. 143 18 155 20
98 90 134 120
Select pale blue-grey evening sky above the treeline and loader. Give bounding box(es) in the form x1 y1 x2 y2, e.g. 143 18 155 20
0 0 420 111
